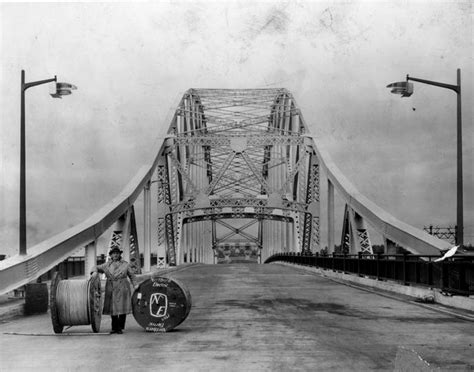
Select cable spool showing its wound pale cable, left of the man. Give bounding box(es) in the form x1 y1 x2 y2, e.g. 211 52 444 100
50 273 102 333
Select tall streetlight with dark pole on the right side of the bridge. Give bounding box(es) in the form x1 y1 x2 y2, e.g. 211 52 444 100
387 68 464 247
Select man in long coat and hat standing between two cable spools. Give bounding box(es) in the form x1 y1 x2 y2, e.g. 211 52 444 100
91 247 137 334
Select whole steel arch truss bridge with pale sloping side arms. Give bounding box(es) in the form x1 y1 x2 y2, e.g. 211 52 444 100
0 89 450 293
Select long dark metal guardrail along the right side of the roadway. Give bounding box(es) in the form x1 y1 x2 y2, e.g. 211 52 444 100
265 253 474 296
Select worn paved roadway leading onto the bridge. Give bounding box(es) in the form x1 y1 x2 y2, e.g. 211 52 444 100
0 264 474 372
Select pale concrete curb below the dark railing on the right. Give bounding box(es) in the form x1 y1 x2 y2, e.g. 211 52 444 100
272 262 474 312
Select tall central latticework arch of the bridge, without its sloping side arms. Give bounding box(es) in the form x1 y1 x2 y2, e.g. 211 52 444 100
158 89 319 264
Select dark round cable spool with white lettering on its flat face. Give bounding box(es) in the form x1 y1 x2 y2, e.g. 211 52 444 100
132 276 192 332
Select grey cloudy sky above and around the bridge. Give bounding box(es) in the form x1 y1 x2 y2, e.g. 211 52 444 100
0 1 474 254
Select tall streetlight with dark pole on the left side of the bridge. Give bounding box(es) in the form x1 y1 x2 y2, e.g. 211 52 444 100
20 70 77 255
